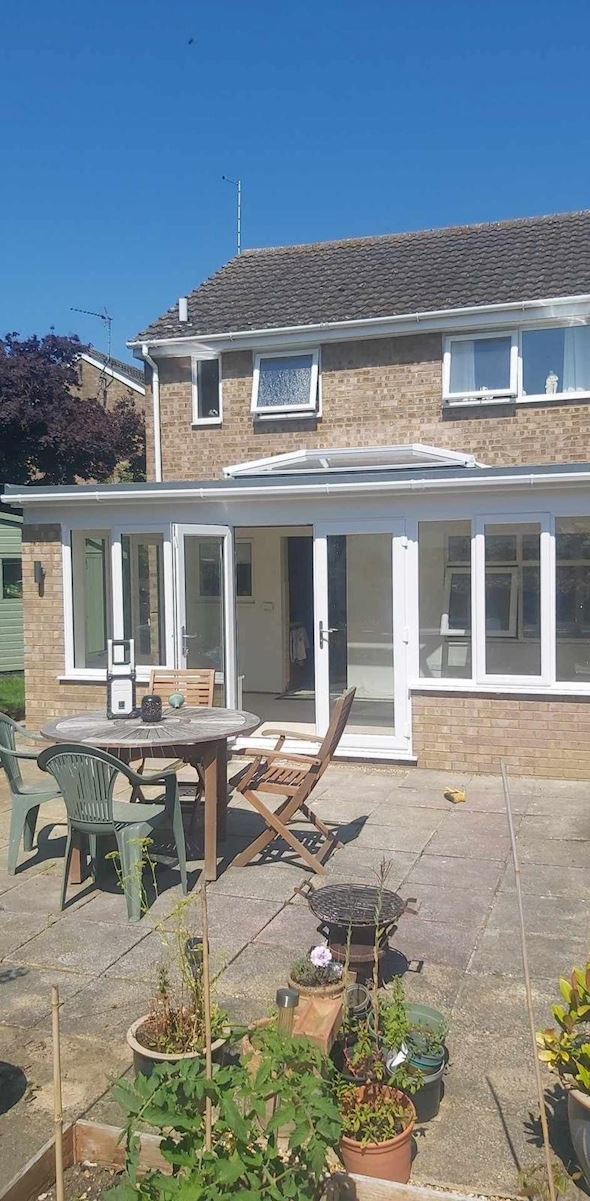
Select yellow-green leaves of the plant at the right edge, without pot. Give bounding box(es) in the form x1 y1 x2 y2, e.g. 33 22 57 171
537 962 590 1094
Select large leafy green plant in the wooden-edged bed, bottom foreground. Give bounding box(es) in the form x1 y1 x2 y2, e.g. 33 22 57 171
108 1029 341 1201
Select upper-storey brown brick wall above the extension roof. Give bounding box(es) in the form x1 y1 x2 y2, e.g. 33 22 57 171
147 334 590 480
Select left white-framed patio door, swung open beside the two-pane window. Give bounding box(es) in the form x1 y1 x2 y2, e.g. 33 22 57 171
174 525 237 707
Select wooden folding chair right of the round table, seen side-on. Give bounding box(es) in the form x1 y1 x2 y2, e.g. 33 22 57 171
233 688 356 874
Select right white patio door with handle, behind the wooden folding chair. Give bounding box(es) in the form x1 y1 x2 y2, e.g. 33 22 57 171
314 521 410 754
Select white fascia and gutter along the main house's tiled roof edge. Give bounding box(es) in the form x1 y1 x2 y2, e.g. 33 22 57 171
127 293 590 357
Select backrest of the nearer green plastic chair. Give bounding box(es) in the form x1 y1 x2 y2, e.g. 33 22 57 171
37 742 127 825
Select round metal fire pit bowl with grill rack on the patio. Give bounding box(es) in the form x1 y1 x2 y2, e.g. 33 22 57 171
309 884 407 975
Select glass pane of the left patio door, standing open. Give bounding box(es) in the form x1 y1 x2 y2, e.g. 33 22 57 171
181 534 224 686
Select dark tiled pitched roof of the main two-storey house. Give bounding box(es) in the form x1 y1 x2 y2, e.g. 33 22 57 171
138 210 590 341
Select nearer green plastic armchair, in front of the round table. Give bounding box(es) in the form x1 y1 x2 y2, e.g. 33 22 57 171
37 742 186 921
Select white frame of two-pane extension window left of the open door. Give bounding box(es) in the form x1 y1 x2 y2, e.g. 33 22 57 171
59 521 175 682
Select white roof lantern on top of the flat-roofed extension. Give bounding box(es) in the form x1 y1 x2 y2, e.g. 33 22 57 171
224 442 481 479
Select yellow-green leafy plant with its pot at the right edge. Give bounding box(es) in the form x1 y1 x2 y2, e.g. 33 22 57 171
537 962 590 1187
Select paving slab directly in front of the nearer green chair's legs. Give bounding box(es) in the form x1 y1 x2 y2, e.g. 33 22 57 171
11 913 145 975
